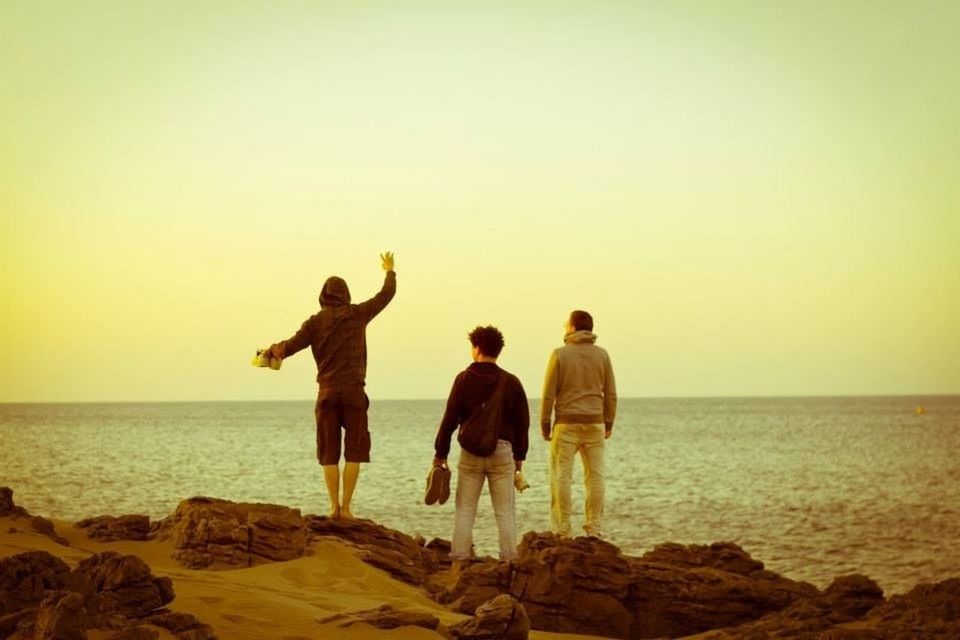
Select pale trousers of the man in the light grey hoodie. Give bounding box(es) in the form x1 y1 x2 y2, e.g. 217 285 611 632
550 423 605 536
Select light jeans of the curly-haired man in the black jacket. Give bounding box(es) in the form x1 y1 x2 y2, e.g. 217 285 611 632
450 440 517 560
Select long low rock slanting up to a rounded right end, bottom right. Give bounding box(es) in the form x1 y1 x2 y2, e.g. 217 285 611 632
703 575 883 640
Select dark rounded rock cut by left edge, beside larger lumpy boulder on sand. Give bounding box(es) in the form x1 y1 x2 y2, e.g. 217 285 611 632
0 551 74 616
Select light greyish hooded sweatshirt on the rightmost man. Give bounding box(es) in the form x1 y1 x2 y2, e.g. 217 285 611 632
540 331 617 428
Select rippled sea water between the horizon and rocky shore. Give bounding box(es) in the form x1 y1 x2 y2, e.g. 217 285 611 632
0 396 960 595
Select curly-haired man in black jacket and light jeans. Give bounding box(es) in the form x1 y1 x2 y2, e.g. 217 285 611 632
433 326 530 561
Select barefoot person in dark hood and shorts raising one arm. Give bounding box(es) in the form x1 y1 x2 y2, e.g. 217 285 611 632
269 252 397 519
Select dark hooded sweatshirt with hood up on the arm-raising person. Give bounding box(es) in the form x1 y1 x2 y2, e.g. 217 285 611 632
281 271 397 387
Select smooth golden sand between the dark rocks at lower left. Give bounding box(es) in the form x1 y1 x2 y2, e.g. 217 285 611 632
0 488 590 640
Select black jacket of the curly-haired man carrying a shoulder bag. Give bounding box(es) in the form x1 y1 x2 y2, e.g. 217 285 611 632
434 362 530 460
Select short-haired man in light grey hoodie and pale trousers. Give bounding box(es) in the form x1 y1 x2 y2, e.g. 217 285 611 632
540 310 617 537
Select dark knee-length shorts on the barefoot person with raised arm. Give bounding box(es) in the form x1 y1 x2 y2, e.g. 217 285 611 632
314 385 370 464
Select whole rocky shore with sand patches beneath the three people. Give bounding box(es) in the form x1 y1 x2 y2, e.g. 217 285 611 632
0 488 960 640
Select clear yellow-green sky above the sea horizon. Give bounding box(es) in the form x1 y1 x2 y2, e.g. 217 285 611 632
0 0 960 402
